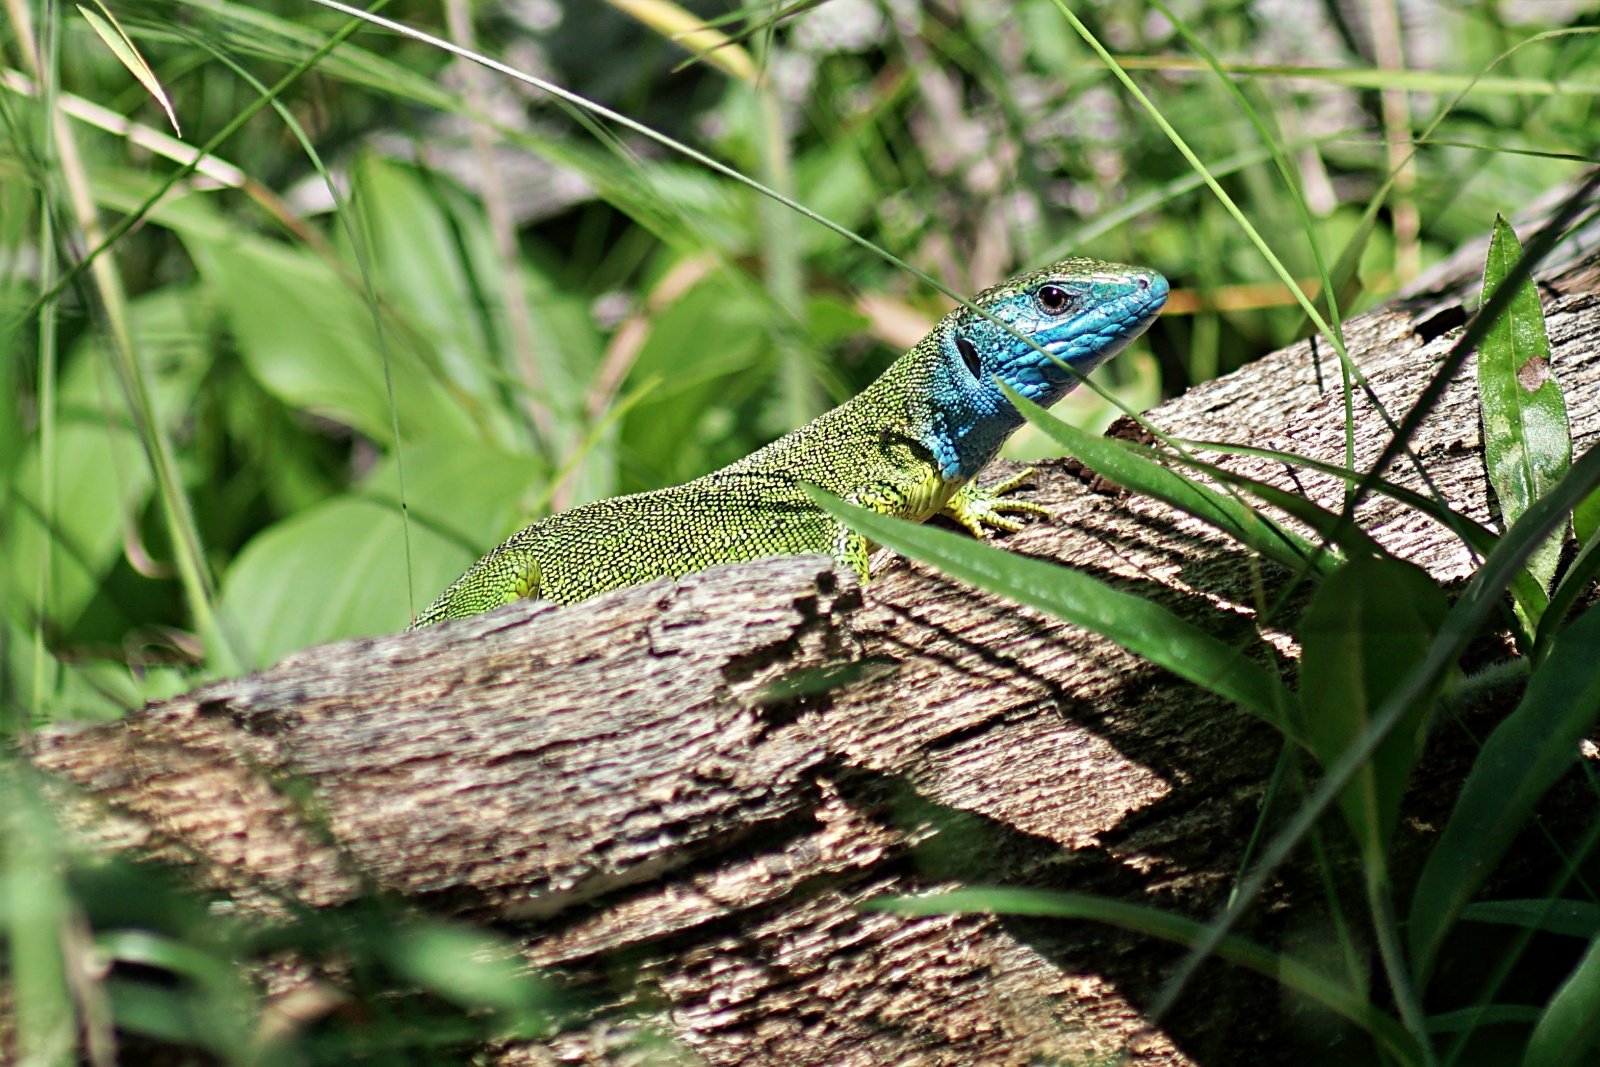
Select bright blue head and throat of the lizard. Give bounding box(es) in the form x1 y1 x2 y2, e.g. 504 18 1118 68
922 259 1166 480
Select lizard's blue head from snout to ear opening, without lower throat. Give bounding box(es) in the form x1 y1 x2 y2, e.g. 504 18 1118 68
939 259 1166 408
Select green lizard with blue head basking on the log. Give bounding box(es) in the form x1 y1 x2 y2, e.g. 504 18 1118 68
411 259 1168 629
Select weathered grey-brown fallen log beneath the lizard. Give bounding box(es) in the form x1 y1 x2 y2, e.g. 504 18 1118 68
21 220 1600 1067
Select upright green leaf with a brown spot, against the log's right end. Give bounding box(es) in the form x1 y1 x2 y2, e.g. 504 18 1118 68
1478 214 1573 598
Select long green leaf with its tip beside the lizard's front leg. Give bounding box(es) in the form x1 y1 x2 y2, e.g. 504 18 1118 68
806 486 1291 733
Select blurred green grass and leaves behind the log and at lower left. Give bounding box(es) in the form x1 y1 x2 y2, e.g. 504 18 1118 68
0 0 1600 1059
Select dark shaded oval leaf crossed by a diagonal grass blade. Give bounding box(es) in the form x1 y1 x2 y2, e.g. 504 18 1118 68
1299 557 1450 853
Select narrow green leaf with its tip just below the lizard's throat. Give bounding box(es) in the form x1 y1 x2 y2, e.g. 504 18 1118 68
1002 384 1338 573
